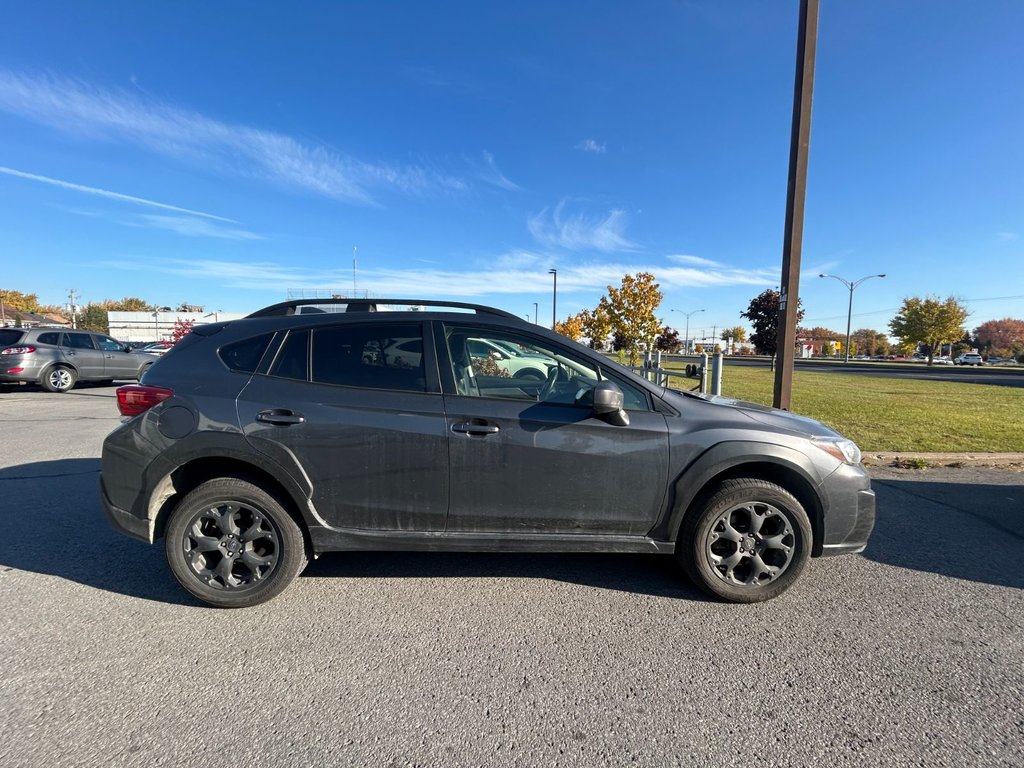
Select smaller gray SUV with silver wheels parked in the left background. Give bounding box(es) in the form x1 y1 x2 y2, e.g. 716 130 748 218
0 328 157 392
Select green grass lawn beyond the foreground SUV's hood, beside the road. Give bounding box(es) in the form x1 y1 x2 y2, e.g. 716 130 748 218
659 362 1024 453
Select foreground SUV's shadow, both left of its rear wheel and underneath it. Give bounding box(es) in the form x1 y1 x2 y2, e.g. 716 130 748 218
0 459 706 605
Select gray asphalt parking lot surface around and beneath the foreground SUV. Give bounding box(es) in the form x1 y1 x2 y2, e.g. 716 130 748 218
0 388 1024 768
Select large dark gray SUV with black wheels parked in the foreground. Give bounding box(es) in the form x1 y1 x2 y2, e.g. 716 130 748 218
100 299 874 607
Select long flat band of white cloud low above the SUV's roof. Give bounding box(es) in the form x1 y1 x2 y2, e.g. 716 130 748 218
104 252 778 298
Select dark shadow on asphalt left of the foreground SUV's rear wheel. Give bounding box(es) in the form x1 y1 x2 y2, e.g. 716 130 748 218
0 459 200 605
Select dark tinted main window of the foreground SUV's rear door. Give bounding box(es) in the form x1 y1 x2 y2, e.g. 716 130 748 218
312 323 427 392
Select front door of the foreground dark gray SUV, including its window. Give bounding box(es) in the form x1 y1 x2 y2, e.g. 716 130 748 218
439 325 669 536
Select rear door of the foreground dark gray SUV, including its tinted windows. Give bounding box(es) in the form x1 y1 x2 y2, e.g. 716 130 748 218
238 321 449 531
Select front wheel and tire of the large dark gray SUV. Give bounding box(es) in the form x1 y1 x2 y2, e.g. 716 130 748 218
676 478 812 603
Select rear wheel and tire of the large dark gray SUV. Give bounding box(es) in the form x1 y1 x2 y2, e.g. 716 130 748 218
164 477 306 608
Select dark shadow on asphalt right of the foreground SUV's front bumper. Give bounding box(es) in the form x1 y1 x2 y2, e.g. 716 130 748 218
864 478 1024 589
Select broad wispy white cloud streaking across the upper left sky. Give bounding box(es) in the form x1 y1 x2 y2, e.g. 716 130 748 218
0 71 466 203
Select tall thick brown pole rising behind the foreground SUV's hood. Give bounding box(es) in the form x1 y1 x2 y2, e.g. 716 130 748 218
772 0 818 411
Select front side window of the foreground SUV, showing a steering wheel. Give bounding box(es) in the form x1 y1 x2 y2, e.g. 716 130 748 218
444 327 650 411
